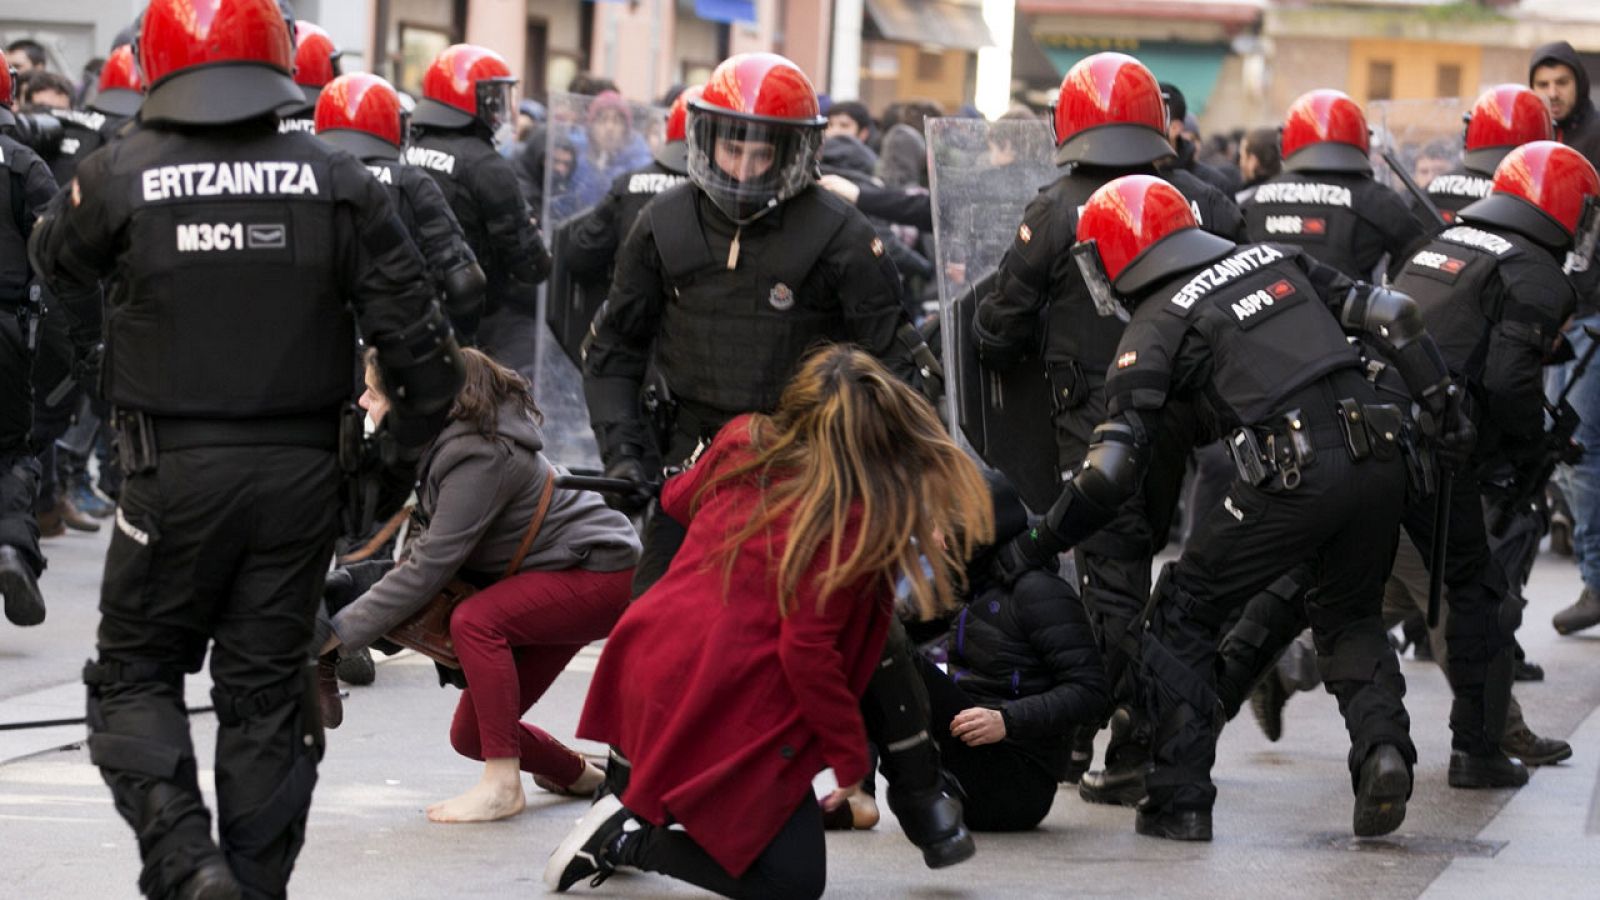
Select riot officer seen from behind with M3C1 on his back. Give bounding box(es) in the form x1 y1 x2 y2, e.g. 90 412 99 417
30 0 461 897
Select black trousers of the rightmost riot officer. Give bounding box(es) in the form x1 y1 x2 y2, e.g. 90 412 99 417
1405 471 1522 754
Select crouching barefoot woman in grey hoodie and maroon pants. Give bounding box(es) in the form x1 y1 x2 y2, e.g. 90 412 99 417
323 349 638 822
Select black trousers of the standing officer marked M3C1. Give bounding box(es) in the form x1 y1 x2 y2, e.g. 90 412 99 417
85 445 339 900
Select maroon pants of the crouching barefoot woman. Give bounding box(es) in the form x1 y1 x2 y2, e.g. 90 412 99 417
450 569 634 785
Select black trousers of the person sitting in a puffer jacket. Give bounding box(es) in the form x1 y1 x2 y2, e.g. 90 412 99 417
917 655 1058 831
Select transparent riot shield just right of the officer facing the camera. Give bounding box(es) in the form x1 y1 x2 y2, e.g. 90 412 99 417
926 119 1061 512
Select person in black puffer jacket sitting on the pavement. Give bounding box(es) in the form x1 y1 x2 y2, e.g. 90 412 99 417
917 472 1110 831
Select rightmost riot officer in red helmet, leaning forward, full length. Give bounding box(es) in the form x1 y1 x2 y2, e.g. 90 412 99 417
1395 141 1600 788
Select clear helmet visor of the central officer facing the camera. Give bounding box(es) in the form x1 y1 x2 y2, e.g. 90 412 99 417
688 110 822 224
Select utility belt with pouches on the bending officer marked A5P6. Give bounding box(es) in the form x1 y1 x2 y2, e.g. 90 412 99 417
1227 399 1405 490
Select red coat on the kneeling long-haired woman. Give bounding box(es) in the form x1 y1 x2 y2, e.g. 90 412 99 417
578 416 893 876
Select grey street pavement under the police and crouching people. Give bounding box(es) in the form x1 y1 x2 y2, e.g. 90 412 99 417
0 522 1600 900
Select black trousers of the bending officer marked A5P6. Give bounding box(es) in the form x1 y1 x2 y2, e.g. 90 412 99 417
1142 447 1416 810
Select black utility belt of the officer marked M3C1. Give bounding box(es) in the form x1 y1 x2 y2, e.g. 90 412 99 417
112 410 339 474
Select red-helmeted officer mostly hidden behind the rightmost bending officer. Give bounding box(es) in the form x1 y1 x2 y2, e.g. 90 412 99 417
1413 85 1555 224
